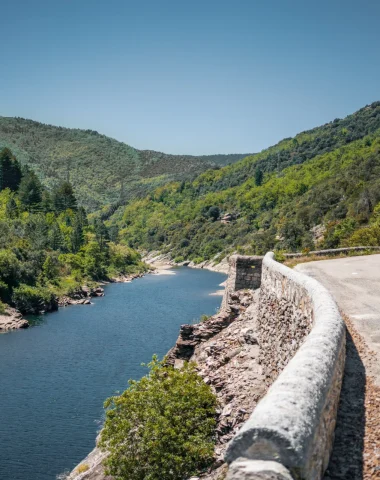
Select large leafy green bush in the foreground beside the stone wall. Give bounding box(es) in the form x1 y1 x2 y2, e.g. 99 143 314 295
100 357 216 480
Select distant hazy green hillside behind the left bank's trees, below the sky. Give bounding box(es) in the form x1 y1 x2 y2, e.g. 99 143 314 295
0 117 246 211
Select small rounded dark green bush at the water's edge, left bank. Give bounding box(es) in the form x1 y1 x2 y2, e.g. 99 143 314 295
12 284 58 314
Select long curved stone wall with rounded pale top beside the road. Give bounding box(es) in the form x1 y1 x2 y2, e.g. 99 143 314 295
226 253 345 480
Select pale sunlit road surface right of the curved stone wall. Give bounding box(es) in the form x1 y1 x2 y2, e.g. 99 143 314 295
296 255 380 385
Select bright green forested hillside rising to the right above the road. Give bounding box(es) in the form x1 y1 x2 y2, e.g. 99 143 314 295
108 102 380 262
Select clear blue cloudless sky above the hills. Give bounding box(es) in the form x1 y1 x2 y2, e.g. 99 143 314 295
0 0 380 154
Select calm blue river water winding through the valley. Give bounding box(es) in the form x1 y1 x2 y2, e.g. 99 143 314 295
0 267 225 480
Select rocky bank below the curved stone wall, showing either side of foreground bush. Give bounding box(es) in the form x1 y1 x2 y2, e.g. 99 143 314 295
66 284 266 480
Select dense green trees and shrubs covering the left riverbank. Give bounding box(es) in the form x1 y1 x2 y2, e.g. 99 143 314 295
0 148 147 313
